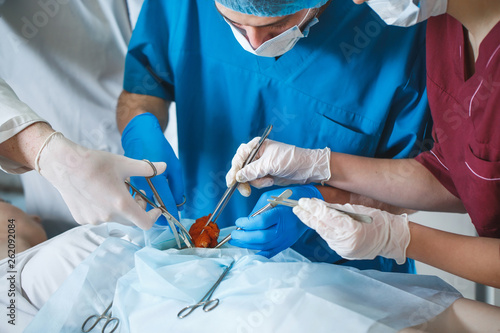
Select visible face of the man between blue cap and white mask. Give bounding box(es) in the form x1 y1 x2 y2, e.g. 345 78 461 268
215 2 314 49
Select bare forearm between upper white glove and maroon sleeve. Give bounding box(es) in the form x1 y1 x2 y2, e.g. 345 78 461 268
326 153 465 212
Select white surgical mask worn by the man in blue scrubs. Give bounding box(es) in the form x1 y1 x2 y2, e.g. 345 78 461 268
224 9 319 58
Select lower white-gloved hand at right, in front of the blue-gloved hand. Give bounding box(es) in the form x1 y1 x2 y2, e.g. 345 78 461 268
293 199 410 265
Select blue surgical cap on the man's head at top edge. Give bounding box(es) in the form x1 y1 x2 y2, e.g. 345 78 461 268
216 0 328 16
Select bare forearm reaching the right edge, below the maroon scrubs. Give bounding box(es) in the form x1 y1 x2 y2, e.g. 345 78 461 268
406 222 500 288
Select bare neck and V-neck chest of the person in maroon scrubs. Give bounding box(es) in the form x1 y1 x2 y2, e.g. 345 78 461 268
447 0 500 60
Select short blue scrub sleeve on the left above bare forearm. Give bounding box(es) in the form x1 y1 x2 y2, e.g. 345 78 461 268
123 1 174 101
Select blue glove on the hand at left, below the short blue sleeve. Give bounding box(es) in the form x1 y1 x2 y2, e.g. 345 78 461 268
122 113 184 225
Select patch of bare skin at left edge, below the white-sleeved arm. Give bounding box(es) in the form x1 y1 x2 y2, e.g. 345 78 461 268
0 202 47 259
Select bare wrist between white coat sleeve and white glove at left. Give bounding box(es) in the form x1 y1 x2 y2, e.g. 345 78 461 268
0 122 54 169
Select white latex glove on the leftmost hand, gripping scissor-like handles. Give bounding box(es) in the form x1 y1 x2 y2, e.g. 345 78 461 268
35 133 166 229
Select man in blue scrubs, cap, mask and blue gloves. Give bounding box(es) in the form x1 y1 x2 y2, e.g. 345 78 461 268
117 0 431 272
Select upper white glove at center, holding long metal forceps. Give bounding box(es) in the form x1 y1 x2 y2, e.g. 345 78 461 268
226 137 330 197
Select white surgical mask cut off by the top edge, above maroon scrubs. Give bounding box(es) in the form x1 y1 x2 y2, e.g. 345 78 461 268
366 0 448 27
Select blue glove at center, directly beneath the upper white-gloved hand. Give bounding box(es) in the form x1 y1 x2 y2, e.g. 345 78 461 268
229 185 323 258
